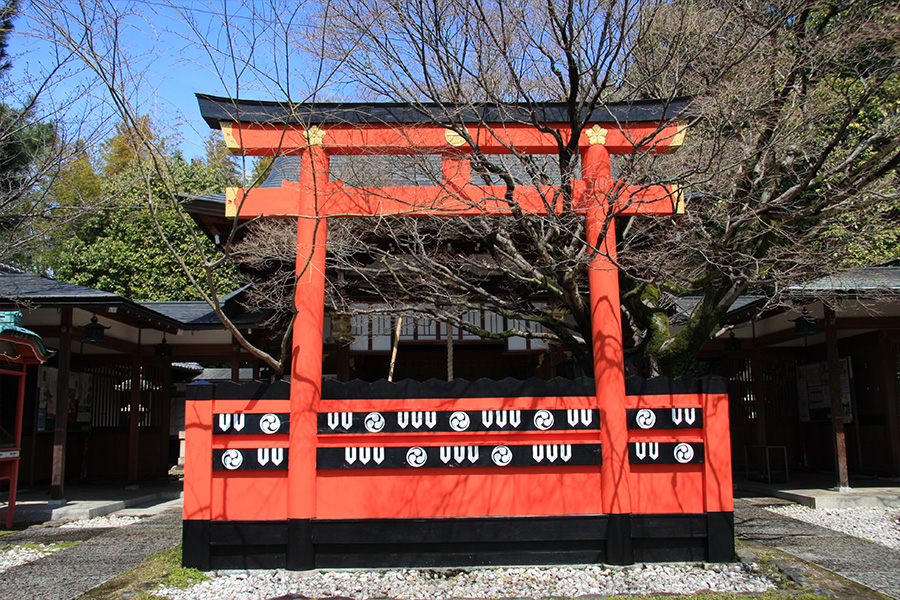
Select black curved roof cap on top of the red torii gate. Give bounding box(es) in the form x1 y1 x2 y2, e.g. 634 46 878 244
197 94 692 129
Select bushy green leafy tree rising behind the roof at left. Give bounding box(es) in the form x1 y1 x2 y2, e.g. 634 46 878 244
48 119 236 300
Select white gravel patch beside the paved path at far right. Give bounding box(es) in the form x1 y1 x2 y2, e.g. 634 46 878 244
766 504 900 550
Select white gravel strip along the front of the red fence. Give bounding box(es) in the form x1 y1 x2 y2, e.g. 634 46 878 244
153 564 774 600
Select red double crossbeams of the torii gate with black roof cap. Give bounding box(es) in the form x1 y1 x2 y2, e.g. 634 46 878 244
197 94 689 218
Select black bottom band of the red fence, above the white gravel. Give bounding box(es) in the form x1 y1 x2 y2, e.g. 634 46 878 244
183 512 734 571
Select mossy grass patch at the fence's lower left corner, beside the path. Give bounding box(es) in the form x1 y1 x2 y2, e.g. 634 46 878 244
76 544 208 600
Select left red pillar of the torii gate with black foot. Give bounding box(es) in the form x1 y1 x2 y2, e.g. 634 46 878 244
287 146 328 569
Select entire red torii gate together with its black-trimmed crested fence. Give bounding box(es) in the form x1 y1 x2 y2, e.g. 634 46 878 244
184 95 734 570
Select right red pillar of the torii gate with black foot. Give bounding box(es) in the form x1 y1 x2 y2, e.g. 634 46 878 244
582 144 634 564
